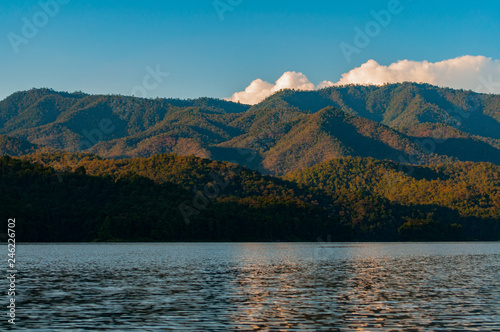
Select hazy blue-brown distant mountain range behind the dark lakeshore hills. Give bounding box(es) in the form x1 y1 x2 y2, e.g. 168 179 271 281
0 83 500 175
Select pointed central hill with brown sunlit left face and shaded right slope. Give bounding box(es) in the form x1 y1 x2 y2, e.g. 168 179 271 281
220 107 451 175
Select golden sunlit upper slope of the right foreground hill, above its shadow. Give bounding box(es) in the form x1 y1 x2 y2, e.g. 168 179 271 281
285 158 500 238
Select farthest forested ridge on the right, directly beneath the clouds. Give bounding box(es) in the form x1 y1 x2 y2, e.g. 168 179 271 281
250 83 500 139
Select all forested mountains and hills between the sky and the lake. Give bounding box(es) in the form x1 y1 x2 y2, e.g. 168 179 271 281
0 83 500 241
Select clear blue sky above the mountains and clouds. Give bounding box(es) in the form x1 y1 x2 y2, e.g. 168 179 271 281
0 0 500 99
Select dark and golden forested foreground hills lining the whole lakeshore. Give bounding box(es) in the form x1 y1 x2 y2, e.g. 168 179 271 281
0 153 500 241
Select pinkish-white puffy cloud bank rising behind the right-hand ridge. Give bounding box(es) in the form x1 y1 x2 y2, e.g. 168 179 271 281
228 56 500 105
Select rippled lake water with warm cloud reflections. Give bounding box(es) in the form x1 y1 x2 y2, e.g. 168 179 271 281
0 242 500 331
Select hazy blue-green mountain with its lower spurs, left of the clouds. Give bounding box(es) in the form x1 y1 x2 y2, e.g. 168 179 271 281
0 89 249 155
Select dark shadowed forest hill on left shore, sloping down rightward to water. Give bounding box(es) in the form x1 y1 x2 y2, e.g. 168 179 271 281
0 156 348 242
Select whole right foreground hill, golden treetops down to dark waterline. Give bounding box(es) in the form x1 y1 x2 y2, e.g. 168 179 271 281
285 157 500 240
